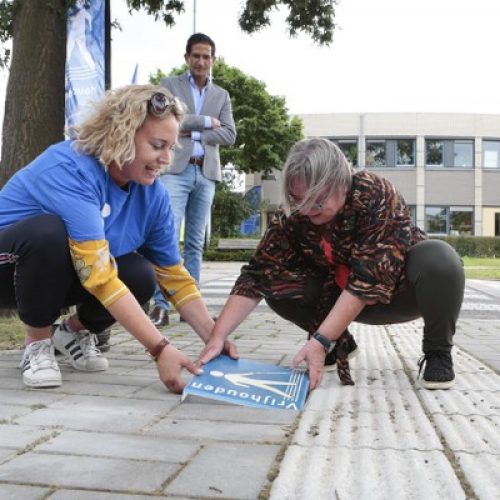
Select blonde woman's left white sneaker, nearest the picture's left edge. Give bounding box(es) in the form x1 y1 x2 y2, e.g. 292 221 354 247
19 339 62 388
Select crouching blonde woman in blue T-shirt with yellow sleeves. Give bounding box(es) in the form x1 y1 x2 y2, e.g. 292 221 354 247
0 85 235 392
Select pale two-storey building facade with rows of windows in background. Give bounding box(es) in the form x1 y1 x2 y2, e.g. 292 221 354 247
249 113 500 236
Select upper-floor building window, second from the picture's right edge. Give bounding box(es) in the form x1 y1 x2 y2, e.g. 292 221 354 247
425 139 474 168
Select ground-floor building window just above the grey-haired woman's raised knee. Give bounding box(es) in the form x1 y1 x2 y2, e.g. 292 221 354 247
425 207 474 236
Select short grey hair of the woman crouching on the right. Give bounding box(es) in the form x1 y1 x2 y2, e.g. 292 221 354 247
282 137 352 213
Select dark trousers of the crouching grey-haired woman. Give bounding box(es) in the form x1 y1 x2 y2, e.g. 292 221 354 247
266 240 465 353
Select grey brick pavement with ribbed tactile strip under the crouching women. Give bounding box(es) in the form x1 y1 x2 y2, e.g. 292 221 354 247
0 263 500 500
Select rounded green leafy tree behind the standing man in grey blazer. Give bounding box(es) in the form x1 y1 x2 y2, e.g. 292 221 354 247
150 59 303 174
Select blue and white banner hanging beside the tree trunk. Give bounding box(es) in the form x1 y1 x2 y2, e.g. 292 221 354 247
66 0 105 126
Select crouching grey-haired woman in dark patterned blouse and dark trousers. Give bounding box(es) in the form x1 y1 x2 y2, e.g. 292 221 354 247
200 138 465 389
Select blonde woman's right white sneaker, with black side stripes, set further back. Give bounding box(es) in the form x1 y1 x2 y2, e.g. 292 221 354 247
52 322 108 372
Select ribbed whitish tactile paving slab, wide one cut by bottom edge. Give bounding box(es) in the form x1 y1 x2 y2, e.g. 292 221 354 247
270 446 466 500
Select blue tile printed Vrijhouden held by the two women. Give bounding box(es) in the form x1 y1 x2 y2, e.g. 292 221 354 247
182 355 309 410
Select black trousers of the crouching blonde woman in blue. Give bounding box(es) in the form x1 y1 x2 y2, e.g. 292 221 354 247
0 215 156 332
